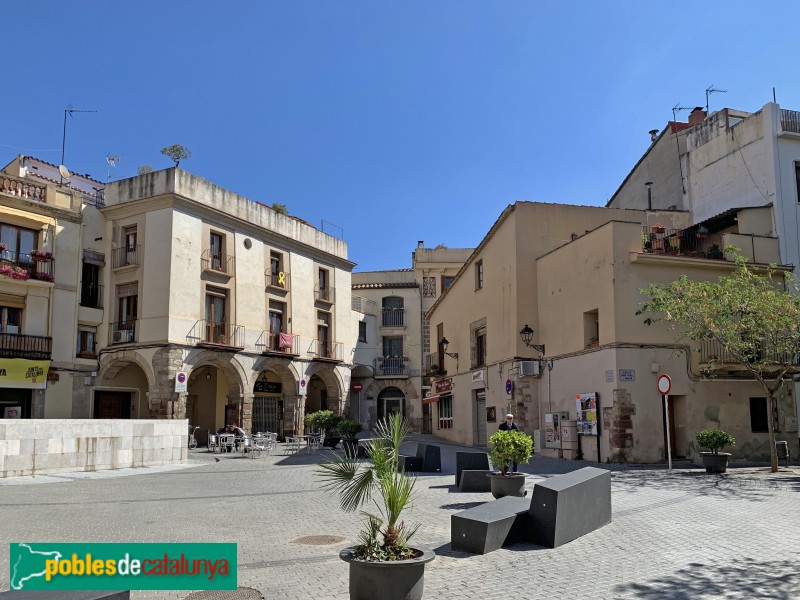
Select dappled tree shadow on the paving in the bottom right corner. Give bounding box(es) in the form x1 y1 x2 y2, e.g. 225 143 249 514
614 556 800 600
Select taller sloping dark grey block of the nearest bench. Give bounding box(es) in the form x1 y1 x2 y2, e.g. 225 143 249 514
529 467 611 548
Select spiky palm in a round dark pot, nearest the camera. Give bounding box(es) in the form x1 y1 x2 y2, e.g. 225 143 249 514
317 414 436 600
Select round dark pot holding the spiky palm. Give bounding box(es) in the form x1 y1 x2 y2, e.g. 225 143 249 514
339 546 436 600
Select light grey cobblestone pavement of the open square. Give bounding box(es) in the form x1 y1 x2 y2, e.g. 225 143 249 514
0 436 800 600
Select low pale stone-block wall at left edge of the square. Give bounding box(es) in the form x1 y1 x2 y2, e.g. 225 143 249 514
0 419 188 477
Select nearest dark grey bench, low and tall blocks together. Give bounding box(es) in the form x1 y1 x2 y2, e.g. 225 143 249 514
450 467 611 554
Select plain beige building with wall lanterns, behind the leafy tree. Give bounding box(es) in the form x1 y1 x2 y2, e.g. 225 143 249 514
428 202 797 463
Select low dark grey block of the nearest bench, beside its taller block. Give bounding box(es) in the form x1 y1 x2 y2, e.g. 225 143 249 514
450 496 530 554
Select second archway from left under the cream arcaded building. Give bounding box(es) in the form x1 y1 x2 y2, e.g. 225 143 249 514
186 364 233 445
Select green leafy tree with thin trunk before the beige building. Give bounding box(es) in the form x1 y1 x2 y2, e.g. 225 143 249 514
636 247 800 472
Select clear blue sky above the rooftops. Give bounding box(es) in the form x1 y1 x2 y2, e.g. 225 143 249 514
0 0 800 270
